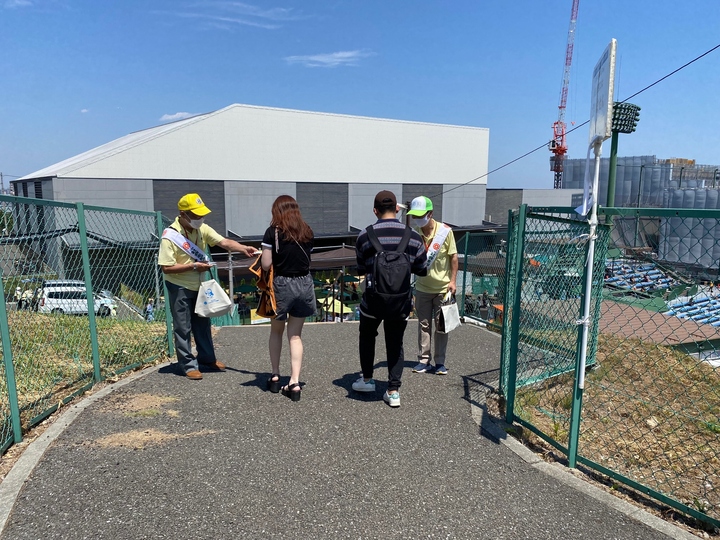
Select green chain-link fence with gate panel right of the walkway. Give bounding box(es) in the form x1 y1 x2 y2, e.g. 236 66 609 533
501 207 720 526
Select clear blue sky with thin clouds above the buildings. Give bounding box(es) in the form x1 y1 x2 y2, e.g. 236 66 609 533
0 0 720 188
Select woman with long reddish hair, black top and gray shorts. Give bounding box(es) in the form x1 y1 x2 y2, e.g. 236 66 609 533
260 195 315 401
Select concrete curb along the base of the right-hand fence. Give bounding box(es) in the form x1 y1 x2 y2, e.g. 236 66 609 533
469 381 698 540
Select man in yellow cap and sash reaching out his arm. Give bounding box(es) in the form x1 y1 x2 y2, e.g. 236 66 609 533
158 193 257 380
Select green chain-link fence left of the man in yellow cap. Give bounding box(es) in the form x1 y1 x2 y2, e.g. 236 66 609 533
0 196 169 452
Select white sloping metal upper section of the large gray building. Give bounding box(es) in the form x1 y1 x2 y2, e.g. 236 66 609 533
18 104 489 184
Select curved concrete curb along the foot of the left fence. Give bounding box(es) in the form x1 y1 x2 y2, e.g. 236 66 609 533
0 362 170 534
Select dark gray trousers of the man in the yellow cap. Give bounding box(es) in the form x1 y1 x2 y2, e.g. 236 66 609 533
165 281 216 373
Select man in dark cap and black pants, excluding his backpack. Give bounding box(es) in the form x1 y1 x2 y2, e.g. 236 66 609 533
352 191 427 407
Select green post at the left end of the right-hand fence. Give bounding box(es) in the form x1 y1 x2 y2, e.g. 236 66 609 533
503 204 528 424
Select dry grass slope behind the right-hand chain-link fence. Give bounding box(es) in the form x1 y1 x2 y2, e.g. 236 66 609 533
516 335 720 519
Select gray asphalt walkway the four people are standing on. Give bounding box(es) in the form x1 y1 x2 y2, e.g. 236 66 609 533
0 323 696 540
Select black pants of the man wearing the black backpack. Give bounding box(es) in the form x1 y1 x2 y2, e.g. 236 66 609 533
360 313 407 392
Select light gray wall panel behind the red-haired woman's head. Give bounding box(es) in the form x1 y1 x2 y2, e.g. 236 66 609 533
225 182 294 236
